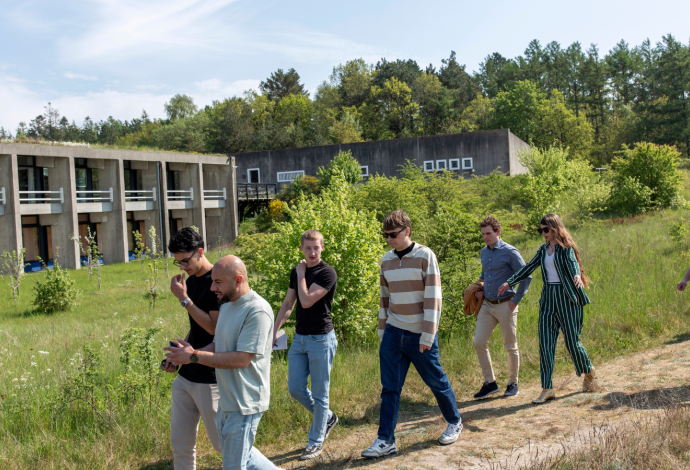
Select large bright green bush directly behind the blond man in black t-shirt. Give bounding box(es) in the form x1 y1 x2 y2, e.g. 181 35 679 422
241 172 384 341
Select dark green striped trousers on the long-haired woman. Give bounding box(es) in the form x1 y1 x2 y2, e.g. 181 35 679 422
539 284 593 388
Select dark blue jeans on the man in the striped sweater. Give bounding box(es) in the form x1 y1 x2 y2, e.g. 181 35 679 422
379 325 461 443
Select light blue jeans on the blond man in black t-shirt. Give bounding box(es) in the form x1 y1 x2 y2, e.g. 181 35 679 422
288 330 338 445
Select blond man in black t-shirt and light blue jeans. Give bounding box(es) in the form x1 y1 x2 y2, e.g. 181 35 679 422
273 230 338 460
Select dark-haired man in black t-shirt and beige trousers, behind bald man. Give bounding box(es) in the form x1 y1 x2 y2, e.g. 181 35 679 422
165 227 222 470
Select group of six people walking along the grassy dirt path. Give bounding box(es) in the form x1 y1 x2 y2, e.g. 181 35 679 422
162 211 600 470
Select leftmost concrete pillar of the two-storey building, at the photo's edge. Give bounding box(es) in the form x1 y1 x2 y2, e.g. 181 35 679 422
0 155 22 253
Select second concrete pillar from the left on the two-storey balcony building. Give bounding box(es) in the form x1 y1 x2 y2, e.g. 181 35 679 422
48 157 81 269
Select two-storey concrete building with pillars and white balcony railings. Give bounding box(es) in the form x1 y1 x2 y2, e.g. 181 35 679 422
0 143 238 270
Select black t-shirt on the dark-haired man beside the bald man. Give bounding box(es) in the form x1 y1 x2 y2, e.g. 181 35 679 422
179 271 220 384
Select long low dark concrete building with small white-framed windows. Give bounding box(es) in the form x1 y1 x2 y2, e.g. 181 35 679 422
233 129 529 185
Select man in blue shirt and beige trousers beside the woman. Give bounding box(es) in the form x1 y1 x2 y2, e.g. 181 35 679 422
474 216 532 400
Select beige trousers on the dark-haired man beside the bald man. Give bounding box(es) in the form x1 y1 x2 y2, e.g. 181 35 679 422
170 375 222 470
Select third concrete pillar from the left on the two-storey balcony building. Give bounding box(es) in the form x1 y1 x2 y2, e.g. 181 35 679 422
98 160 129 264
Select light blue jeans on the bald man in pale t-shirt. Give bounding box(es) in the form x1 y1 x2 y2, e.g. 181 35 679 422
218 407 278 470
